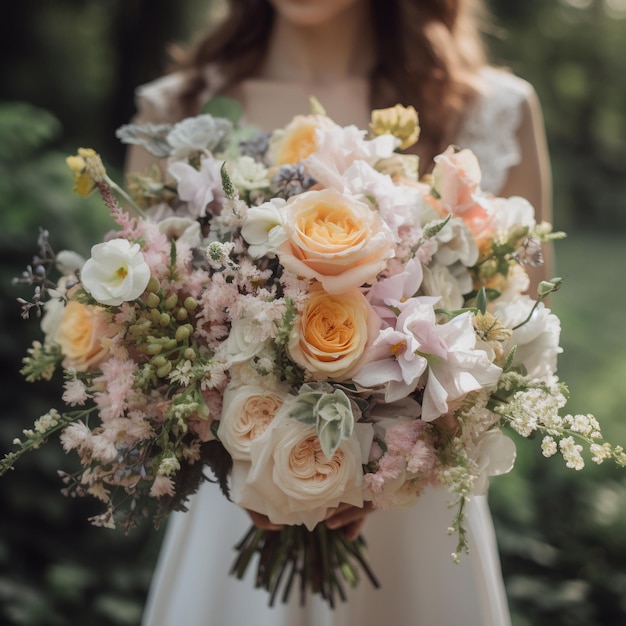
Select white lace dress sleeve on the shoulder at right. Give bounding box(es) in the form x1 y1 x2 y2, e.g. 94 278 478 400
457 68 534 195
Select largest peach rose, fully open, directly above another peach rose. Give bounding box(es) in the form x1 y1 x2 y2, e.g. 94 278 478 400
278 189 394 293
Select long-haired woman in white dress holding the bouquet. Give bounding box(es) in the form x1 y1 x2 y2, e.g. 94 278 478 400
127 0 551 626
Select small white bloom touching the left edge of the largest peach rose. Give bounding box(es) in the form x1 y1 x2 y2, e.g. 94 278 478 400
241 198 288 259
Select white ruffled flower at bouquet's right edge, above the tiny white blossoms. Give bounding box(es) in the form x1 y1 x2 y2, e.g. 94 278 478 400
493 295 562 379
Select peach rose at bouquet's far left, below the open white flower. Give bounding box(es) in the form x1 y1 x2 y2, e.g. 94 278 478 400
50 300 115 372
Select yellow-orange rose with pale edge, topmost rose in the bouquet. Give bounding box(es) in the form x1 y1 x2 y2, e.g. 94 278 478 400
269 115 336 165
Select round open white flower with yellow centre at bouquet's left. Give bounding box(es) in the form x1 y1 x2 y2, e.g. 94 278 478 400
81 239 150 306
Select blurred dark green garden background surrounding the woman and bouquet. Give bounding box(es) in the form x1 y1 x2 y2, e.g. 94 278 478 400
0 0 626 626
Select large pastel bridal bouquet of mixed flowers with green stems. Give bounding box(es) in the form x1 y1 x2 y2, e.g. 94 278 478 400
1 101 626 605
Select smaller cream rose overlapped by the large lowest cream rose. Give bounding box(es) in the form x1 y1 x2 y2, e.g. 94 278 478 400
217 385 285 461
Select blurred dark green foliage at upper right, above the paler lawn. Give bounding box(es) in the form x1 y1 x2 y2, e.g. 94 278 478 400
488 0 626 231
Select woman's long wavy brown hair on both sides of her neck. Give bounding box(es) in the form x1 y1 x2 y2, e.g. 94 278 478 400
169 0 487 162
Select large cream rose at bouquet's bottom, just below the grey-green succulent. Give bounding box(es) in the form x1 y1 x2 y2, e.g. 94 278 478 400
232 405 373 530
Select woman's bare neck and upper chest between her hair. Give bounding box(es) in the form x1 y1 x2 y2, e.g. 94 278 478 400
257 2 376 84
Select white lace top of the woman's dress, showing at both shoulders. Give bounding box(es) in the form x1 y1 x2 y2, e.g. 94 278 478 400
136 68 532 194
